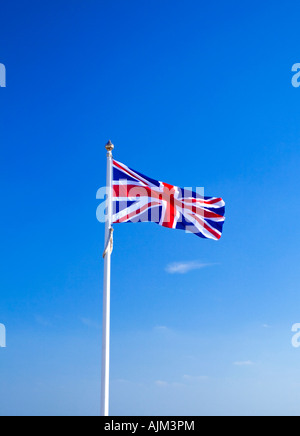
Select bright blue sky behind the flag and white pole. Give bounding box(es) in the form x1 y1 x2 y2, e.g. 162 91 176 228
0 0 300 415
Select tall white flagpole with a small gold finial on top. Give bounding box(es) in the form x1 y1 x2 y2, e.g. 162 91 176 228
101 141 114 416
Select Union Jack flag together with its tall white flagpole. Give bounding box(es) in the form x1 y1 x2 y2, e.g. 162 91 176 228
101 141 225 416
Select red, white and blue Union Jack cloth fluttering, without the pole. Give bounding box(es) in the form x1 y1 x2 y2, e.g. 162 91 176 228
112 160 225 240
